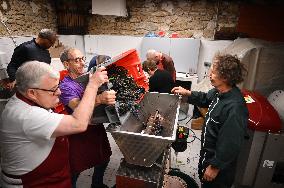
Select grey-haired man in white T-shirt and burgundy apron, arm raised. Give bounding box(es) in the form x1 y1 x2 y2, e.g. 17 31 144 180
0 61 108 188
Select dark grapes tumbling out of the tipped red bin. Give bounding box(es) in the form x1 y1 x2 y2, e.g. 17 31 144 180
107 64 145 116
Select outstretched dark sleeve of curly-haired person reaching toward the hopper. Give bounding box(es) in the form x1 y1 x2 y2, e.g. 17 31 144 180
188 89 216 108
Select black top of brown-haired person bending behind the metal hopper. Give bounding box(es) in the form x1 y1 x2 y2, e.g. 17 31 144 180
149 69 174 93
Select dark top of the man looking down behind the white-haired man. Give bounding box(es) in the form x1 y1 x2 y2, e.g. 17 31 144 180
7 39 51 81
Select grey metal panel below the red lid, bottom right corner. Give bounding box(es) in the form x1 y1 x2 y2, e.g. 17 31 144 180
235 130 284 188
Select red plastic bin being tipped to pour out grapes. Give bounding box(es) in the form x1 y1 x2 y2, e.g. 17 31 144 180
112 49 149 91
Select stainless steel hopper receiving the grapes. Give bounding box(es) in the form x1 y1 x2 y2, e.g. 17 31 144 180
110 92 180 167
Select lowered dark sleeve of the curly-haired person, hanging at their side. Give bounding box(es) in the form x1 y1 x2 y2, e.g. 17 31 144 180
209 104 248 169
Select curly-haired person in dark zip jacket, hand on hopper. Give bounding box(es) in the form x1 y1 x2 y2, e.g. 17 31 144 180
172 54 248 188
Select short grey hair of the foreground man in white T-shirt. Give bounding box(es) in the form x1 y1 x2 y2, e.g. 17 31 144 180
16 61 59 93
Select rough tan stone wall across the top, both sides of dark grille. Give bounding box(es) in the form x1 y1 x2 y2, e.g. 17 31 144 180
0 0 239 39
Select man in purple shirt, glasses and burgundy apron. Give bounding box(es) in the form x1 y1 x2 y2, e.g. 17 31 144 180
60 48 115 188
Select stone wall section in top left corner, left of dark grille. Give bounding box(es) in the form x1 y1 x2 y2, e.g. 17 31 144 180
0 0 57 36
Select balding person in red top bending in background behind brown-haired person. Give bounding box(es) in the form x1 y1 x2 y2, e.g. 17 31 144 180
146 49 176 82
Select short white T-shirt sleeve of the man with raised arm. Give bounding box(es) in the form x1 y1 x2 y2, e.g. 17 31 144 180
23 106 64 140
